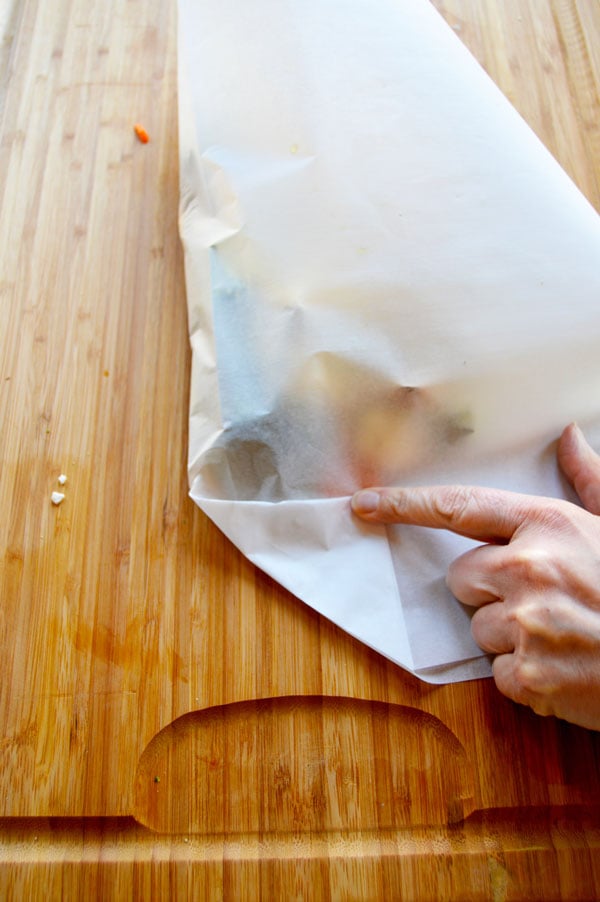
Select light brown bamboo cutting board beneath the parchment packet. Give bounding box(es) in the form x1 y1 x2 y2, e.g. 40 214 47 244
0 0 600 900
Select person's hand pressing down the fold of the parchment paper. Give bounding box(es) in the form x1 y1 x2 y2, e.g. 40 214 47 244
352 424 600 730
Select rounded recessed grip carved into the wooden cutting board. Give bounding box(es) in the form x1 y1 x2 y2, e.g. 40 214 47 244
134 696 473 836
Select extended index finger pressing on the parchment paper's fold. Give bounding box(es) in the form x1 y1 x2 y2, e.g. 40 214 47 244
352 485 546 544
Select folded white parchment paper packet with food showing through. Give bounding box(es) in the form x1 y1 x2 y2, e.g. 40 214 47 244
179 0 600 682
